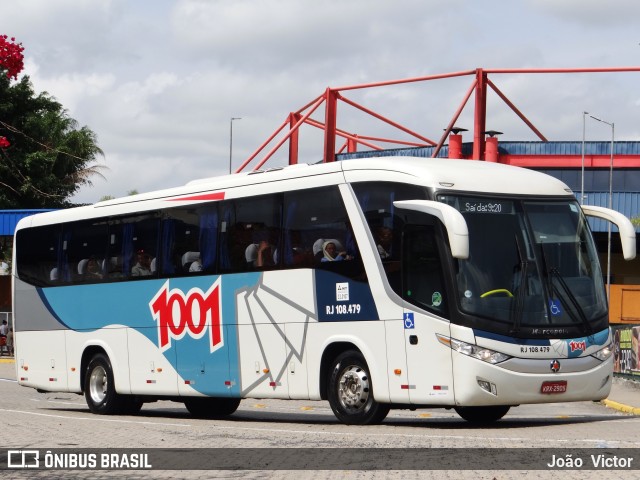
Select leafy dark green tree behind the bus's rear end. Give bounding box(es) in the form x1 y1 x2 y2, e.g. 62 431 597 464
0 75 106 209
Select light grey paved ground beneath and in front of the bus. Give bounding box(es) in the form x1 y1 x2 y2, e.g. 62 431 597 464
0 358 640 480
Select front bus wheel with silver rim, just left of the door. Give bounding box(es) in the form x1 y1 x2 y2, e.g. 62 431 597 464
328 350 389 425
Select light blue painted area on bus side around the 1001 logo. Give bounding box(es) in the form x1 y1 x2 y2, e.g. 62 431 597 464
39 273 260 396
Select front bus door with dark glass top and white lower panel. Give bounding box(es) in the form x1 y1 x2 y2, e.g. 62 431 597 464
402 225 453 405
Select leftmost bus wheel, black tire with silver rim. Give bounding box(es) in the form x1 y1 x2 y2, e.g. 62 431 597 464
84 353 127 415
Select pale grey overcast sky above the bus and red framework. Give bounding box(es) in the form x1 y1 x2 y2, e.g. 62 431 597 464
0 0 640 202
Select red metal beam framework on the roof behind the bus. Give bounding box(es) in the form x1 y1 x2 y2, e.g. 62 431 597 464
237 67 640 172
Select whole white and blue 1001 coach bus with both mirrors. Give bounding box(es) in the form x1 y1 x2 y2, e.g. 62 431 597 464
13 157 635 424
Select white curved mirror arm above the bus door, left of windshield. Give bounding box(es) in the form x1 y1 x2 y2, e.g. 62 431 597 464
393 200 469 260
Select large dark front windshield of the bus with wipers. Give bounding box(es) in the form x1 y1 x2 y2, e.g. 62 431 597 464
438 195 607 336
